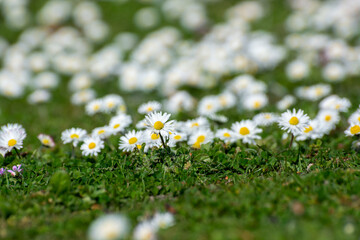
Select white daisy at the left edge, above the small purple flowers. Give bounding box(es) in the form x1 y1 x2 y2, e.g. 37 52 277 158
0 127 26 153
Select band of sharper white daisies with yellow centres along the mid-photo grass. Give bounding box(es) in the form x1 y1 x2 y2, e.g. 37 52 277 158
56 92 360 156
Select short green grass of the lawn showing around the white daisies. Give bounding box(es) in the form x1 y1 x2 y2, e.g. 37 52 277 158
0 0 360 240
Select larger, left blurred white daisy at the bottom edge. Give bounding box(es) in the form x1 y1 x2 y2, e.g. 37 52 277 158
88 214 130 240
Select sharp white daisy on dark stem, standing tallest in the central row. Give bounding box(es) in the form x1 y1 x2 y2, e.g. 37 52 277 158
145 112 174 137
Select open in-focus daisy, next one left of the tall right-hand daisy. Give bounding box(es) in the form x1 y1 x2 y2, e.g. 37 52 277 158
231 120 262 144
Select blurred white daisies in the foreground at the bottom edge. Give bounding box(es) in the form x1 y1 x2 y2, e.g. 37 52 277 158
88 212 175 240
